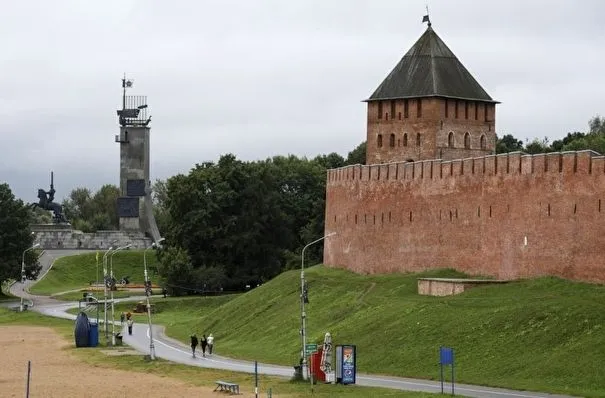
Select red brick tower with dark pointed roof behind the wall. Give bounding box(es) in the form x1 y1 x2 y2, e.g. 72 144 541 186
365 22 499 164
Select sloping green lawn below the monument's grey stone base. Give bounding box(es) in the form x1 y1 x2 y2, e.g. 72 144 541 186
30 250 157 297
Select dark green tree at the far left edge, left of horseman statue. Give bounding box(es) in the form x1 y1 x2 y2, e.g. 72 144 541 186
0 184 41 282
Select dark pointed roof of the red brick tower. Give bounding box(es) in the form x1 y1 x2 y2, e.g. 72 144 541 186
366 26 497 102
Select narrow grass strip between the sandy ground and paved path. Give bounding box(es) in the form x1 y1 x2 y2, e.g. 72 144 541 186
0 308 436 398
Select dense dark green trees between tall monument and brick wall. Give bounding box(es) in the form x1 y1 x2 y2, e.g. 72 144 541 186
156 144 365 294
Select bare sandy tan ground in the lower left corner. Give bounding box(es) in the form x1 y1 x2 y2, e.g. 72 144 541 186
0 326 248 398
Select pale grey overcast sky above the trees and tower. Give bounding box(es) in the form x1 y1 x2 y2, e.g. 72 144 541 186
0 0 605 201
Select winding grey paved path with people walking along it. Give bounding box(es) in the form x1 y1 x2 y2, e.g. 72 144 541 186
11 250 570 398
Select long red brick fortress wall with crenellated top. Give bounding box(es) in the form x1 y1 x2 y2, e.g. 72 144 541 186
324 151 605 282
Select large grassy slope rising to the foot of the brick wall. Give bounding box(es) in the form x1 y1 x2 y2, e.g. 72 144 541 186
113 266 605 397
